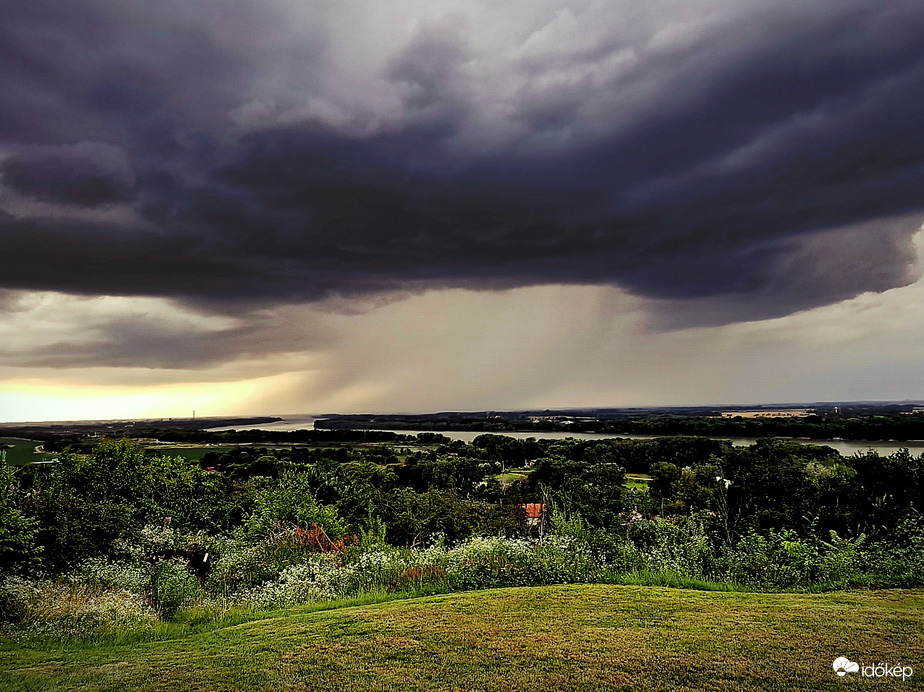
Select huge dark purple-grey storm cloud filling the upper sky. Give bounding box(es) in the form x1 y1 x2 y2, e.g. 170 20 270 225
0 1 924 320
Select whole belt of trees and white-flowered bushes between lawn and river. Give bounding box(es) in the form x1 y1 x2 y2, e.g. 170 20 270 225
0 435 924 643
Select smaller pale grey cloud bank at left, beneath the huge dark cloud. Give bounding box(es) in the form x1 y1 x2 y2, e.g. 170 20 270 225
0 292 334 375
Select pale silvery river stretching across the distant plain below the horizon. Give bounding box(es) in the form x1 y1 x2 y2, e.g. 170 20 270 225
204 415 924 457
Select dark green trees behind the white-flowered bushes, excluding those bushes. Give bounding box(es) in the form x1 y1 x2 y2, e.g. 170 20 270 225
0 434 924 573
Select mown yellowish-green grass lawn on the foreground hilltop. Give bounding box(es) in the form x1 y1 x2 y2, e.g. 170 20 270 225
0 585 924 692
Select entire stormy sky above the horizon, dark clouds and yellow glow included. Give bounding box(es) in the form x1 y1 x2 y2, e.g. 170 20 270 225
0 0 924 421
